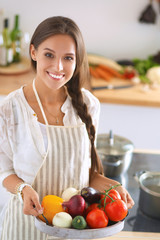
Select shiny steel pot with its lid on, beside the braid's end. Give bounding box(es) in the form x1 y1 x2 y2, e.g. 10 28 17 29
96 131 134 177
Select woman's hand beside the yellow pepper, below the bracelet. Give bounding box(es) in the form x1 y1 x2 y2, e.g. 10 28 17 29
22 186 43 217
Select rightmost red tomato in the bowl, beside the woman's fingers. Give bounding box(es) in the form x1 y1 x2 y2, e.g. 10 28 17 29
105 199 128 222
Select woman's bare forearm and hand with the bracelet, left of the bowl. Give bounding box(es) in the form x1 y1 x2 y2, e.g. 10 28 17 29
3 174 43 216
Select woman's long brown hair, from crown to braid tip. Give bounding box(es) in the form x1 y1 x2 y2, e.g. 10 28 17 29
30 16 103 180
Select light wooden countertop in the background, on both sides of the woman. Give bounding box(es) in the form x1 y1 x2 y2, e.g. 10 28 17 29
0 70 160 107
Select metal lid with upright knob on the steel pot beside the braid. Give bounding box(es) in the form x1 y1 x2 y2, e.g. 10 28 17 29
97 131 134 156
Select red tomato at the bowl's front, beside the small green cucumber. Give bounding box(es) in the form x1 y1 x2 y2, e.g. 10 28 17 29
86 208 108 228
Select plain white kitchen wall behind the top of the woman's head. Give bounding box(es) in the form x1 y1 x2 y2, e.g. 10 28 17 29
0 0 160 60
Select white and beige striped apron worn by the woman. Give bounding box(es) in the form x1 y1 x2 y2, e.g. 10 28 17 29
1 82 90 240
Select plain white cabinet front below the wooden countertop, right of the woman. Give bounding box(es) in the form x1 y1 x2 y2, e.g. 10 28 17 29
98 103 160 150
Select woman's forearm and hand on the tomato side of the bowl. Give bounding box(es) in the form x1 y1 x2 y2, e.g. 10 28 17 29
90 173 134 208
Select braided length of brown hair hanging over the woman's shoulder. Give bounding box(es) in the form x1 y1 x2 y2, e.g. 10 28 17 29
67 77 103 181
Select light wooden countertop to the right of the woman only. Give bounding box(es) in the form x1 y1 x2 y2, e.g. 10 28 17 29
91 79 160 107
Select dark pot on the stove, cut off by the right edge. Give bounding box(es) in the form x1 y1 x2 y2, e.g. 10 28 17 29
135 171 160 219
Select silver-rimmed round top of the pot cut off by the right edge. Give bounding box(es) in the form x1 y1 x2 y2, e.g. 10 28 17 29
139 172 160 197
